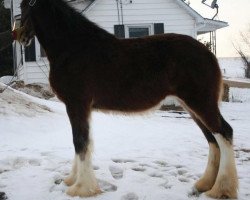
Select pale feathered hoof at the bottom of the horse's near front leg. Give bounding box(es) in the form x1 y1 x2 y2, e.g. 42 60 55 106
67 184 102 197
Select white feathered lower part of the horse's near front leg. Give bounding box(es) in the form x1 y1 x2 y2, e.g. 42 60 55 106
67 140 101 197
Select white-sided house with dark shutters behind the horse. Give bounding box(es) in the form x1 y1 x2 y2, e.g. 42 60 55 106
5 0 228 83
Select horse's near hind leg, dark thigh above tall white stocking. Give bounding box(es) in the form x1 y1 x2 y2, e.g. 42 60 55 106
184 97 238 198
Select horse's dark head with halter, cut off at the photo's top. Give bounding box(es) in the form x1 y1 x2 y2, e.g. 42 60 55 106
17 0 36 46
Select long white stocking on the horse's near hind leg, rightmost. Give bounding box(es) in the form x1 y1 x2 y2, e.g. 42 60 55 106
207 134 238 198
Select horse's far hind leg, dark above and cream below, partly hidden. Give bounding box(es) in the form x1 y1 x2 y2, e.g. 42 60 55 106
187 112 220 193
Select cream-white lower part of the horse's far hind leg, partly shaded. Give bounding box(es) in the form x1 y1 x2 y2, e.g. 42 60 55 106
195 143 220 192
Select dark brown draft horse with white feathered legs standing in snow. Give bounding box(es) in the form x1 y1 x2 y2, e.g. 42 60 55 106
20 0 238 198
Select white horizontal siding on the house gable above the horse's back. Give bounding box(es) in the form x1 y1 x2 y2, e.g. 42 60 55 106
86 0 196 37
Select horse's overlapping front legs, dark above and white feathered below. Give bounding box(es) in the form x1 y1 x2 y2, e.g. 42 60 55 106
65 103 100 197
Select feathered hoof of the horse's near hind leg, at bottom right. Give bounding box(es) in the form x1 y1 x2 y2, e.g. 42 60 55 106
205 189 237 199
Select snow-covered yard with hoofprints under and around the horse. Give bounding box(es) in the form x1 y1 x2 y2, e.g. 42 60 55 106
0 85 250 200
